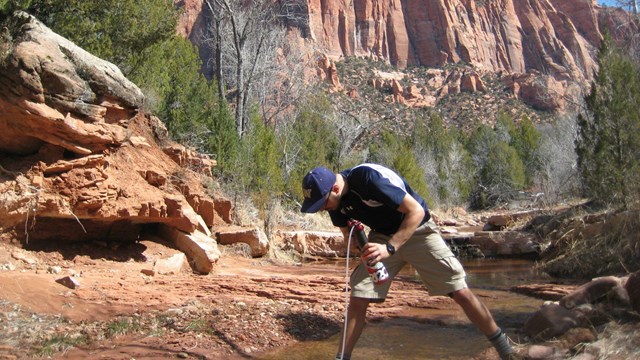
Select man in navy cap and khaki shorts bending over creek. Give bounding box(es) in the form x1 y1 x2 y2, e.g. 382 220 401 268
301 163 515 360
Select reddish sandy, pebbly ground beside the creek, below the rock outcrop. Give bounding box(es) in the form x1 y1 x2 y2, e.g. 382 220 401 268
0 239 496 359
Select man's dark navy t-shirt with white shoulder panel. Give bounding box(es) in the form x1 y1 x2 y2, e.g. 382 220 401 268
329 164 429 235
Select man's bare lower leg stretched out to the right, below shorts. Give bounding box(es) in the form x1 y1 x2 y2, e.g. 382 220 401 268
451 288 515 359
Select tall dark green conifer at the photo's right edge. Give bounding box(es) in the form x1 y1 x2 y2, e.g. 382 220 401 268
576 37 640 206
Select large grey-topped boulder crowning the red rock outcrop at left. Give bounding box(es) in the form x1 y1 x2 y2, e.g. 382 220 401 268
0 12 144 155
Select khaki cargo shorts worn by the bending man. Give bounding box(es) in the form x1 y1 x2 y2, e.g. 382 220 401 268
351 220 467 302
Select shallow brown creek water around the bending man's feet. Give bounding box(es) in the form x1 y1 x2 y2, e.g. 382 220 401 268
257 259 549 360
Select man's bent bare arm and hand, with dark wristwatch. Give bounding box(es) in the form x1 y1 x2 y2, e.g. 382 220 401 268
363 194 425 263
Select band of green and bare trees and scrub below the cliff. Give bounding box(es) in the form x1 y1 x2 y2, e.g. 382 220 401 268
1 0 640 219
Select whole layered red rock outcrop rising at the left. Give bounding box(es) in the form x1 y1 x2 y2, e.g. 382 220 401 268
0 13 232 272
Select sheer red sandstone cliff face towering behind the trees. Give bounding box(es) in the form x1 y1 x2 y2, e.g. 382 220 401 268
178 0 637 111
